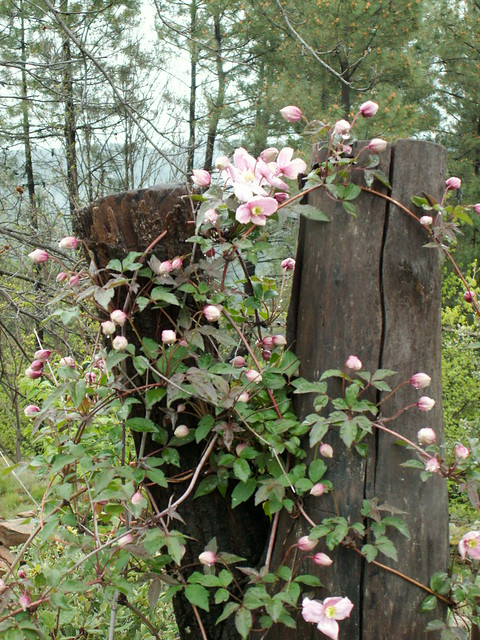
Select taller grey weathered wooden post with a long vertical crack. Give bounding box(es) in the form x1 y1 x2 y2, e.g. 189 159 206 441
269 140 448 640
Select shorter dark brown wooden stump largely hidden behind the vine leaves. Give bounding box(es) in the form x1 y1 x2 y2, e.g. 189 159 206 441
75 184 268 640
